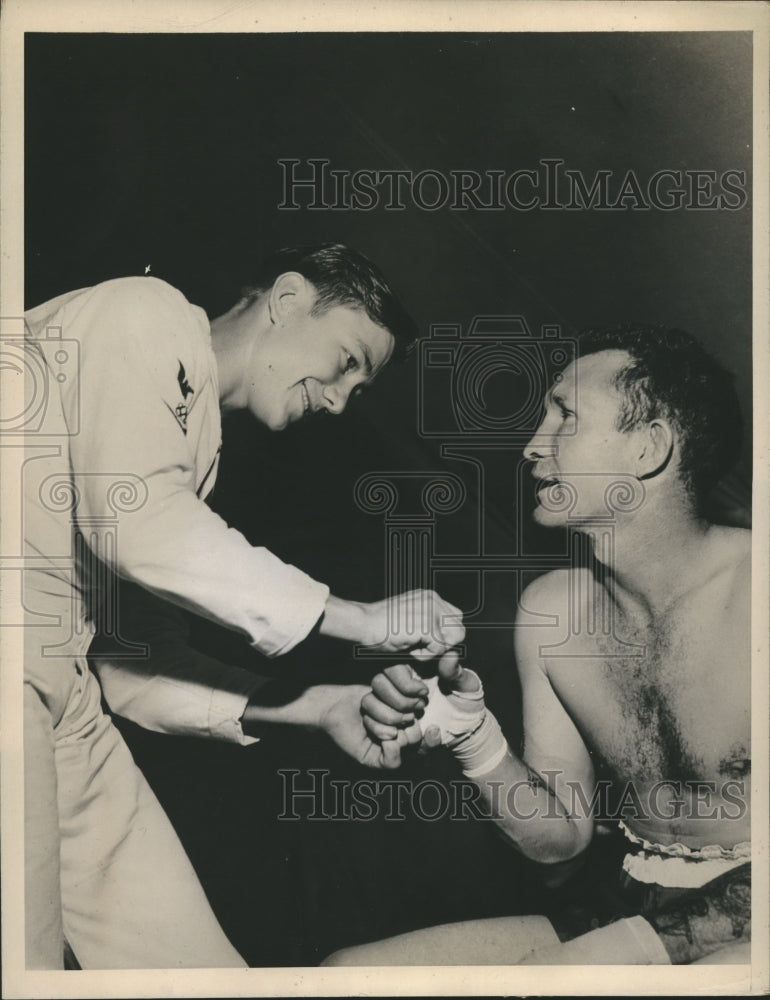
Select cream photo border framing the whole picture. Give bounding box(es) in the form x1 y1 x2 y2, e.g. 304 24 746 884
0 0 770 998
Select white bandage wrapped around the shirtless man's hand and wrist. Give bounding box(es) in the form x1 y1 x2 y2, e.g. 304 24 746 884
420 668 508 778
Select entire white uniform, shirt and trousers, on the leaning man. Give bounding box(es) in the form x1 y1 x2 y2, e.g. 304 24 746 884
21 278 328 969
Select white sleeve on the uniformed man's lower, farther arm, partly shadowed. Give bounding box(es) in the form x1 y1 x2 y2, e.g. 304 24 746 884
89 581 269 746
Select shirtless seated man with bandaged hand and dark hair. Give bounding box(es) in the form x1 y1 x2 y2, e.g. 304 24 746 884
327 329 750 965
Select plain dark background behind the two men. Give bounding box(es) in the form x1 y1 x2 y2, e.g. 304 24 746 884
25 33 752 965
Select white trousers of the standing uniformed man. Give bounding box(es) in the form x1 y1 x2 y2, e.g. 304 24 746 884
24 637 246 969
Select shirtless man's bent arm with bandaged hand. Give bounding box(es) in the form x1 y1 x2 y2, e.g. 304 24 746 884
362 574 594 863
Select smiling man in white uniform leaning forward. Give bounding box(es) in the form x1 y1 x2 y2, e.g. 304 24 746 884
23 244 456 969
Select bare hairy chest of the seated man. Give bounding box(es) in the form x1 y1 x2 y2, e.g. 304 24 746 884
548 595 750 784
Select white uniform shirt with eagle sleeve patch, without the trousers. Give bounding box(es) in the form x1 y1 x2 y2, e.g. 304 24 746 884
26 277 329 742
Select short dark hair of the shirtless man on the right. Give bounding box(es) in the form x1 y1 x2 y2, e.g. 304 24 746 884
578 326 743 512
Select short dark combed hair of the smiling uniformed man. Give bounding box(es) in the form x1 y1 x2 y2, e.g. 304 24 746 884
241 243 418 361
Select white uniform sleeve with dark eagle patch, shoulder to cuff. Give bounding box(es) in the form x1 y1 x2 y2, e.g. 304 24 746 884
57 279 329 656
